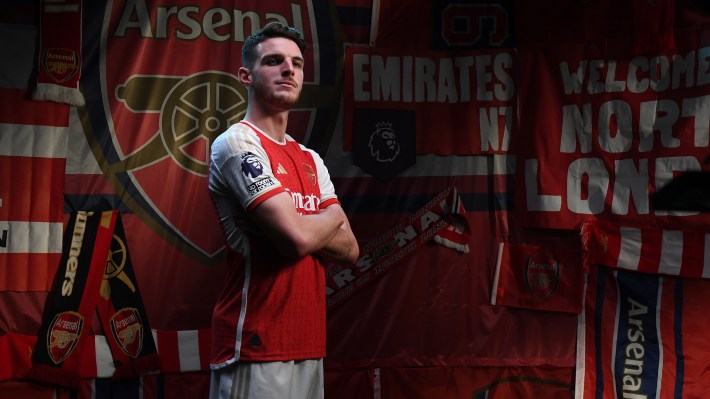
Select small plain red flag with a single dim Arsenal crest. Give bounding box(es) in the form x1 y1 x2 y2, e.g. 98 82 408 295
491 242 584 313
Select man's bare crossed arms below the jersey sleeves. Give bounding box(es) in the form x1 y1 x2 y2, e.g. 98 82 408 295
252 192 359 263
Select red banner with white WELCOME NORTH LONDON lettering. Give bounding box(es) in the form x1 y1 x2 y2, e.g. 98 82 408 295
515 36 710 229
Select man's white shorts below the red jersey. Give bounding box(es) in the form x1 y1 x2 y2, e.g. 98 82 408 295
210 359 324 399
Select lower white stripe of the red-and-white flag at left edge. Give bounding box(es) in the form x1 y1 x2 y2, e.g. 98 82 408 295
0 221 64 253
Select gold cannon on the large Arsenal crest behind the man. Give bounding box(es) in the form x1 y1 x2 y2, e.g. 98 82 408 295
115 71 341 176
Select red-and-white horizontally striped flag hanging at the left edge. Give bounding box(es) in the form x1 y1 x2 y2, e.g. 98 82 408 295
0 85 69 291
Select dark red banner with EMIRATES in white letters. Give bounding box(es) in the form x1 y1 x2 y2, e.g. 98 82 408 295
343 46 517 156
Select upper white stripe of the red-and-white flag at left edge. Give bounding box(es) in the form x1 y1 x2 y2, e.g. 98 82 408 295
0 123 69 158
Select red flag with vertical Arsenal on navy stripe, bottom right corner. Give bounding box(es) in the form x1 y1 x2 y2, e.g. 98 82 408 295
575 267 710 399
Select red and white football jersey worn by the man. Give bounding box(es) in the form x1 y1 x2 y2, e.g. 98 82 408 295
209 121 338 369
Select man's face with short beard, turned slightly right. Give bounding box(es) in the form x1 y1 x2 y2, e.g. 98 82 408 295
251 37 303 110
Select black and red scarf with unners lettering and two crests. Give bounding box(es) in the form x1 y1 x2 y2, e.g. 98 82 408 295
28 211 159 387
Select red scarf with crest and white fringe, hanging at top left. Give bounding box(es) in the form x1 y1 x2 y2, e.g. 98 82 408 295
32 0 85 106
